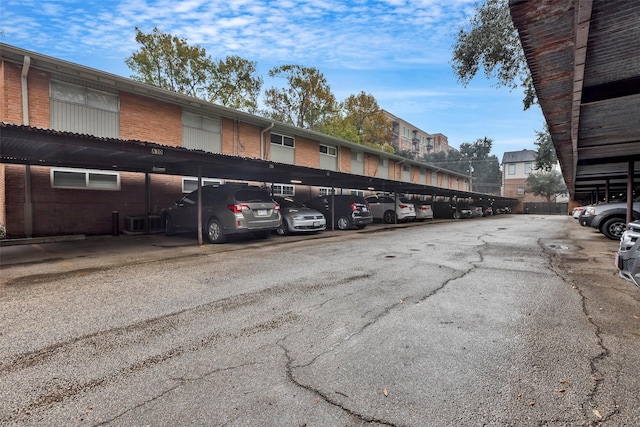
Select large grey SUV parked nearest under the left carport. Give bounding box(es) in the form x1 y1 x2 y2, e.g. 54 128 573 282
161 184 281 243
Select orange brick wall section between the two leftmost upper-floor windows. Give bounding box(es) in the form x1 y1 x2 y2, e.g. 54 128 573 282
120 92 182 147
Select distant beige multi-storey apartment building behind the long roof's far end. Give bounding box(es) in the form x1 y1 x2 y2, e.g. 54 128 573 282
383 110 454 159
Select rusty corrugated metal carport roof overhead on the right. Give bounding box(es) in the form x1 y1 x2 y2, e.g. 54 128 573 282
509 0 640 221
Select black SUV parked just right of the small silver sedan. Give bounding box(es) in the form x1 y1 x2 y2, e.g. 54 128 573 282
304 194 373 230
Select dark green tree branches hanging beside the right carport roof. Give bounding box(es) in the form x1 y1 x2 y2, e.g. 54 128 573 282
452 0 537 110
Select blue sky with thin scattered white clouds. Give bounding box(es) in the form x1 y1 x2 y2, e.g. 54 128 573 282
0 0 544 160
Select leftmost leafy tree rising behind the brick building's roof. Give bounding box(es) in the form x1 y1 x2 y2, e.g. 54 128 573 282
125 27 209 98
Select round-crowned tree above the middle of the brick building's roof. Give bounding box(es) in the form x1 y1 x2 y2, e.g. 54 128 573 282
264 65 336 130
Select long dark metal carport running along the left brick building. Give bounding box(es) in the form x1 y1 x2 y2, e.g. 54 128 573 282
0 123 513 244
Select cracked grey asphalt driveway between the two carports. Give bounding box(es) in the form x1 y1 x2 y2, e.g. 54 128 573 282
0 215 640 426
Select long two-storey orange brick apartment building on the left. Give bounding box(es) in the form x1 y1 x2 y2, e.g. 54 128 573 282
0 44 470 241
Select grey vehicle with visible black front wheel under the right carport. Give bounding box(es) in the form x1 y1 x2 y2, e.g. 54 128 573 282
579 201 640 240
